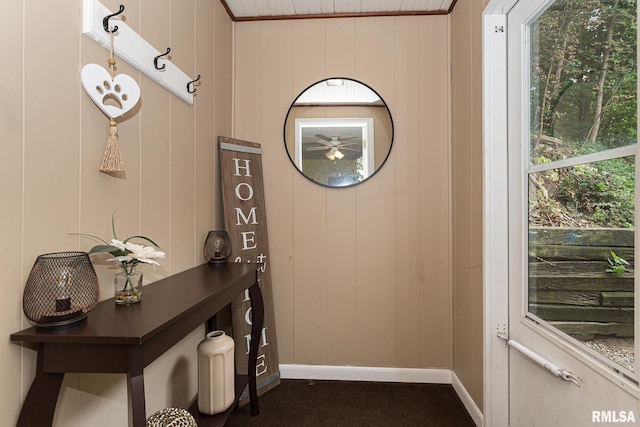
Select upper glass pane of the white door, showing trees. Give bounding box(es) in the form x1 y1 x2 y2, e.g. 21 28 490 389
529 0 637 164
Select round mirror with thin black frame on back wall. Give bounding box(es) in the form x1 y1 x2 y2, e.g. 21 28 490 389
284 77 393 187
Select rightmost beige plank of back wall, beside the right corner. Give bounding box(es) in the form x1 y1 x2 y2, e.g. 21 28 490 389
419 17 452 368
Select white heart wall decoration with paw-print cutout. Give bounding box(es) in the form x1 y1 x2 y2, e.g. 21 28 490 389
80 64 140 119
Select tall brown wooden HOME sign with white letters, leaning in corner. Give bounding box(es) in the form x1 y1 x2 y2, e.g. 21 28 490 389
218 137 280 400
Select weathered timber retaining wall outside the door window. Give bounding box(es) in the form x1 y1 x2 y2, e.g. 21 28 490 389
529 227 634 340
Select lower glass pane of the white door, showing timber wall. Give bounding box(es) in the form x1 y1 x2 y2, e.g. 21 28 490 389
528 157 635 371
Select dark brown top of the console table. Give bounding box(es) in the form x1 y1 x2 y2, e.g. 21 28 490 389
11 263 258 345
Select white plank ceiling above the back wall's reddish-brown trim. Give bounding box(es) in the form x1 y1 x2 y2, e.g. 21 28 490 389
221 0 456 21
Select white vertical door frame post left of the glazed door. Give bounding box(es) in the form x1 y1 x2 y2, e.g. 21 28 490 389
482 0 640 426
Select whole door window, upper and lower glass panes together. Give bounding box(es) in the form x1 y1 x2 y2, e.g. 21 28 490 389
527 0 637 371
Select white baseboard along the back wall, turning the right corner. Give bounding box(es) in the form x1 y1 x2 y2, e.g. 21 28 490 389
280 364 482 426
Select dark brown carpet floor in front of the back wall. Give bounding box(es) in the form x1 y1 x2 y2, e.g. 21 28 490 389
227 380 475 427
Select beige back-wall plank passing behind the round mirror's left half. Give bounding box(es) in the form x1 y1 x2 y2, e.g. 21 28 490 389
293 20 331 364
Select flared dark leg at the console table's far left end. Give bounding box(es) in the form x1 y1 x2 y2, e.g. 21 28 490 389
17 344 64 427
